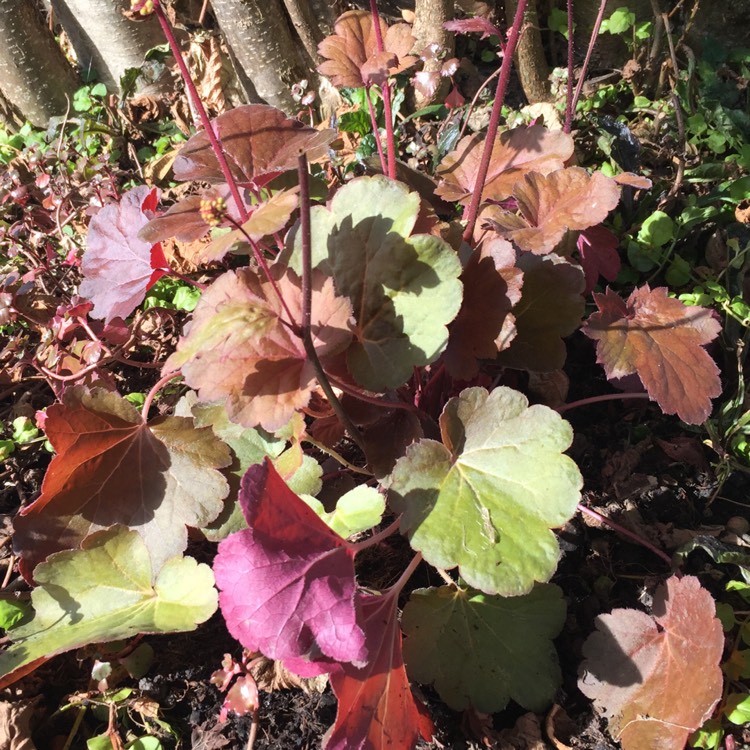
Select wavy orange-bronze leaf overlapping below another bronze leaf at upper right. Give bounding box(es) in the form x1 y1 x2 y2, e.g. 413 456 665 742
491 167 620 255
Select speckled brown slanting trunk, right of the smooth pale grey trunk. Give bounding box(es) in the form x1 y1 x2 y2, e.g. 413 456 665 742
212 0 317 114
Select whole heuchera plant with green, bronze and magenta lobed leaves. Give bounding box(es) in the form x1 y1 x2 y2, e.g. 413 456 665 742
0 2 721 750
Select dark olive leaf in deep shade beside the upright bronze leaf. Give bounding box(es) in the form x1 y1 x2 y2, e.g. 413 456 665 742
497 253 585 372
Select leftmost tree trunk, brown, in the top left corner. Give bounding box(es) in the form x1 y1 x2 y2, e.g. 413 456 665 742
0 0 80 126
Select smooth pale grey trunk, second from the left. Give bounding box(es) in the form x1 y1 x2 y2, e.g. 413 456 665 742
52 0 165 93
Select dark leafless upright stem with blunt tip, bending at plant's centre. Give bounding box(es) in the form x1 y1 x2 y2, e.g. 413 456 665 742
297 154 365 453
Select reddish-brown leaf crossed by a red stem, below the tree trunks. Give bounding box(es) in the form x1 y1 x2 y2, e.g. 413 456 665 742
173 104 336 183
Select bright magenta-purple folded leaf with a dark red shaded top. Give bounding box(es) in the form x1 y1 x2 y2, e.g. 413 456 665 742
214 459 367 677
